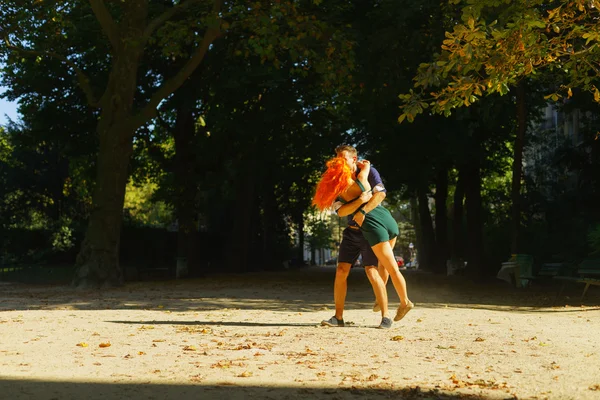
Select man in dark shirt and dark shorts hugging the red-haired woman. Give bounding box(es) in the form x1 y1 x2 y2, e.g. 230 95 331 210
321 145 392 328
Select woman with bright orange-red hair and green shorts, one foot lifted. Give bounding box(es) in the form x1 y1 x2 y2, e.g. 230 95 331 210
313 157 414 321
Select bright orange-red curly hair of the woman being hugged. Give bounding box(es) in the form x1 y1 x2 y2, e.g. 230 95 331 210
312 157 352 211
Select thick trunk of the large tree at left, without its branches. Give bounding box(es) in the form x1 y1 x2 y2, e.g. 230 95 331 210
73 28 140 288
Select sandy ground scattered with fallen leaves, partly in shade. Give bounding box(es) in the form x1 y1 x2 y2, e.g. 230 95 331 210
0 267 600 400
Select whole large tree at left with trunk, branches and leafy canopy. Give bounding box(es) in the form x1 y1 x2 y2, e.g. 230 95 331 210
0 0 354 287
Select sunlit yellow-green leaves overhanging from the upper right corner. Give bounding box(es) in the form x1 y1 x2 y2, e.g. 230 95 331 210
399 0 600 122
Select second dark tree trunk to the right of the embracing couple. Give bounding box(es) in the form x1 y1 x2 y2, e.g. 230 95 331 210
433 166 448 273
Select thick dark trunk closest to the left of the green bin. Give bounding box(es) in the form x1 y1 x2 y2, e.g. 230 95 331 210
464 160 483 278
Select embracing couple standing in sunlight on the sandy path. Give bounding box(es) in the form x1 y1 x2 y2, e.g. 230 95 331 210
313 146 414 329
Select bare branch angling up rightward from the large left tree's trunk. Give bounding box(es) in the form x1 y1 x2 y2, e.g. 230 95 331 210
134 0 223 127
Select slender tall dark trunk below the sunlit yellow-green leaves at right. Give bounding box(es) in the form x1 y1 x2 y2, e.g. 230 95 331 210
510 81 527 254
